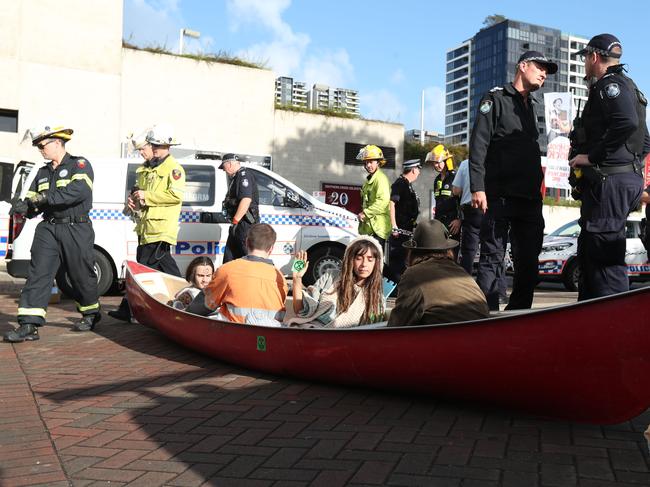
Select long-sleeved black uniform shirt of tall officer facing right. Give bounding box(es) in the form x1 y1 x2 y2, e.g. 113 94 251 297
469 83 543 199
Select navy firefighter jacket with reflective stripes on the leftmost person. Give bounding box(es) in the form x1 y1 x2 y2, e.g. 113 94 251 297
27 153 94 219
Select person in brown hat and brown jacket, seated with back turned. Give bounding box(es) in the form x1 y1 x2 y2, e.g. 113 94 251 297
388 220 490 326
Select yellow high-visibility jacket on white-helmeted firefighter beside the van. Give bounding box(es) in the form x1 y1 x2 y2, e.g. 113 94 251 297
135 155 185 245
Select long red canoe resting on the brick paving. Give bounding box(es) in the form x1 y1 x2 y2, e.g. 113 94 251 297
127 262 650 424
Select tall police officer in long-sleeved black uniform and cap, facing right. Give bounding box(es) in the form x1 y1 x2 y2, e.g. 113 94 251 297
469 51 557 310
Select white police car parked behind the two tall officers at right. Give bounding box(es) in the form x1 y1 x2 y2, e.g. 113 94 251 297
539 215 650 291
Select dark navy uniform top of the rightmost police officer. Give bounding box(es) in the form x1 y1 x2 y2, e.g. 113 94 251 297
582 64 650 165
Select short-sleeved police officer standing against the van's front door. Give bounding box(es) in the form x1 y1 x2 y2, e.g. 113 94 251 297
219 154 260 264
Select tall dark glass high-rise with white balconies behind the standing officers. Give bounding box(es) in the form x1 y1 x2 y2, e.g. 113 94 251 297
445 19 588 150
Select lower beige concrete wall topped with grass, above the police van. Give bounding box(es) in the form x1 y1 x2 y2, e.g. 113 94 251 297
121 49 275 155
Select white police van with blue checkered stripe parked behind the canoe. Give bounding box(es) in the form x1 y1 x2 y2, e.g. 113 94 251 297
7 157 358 294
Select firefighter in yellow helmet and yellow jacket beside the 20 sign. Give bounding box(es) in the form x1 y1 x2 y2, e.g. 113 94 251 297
357 145 392 249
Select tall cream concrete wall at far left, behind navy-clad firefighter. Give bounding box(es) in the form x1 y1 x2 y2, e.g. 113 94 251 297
0 0 122 162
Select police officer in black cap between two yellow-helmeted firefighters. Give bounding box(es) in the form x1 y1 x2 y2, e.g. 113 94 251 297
388 159 422 282
